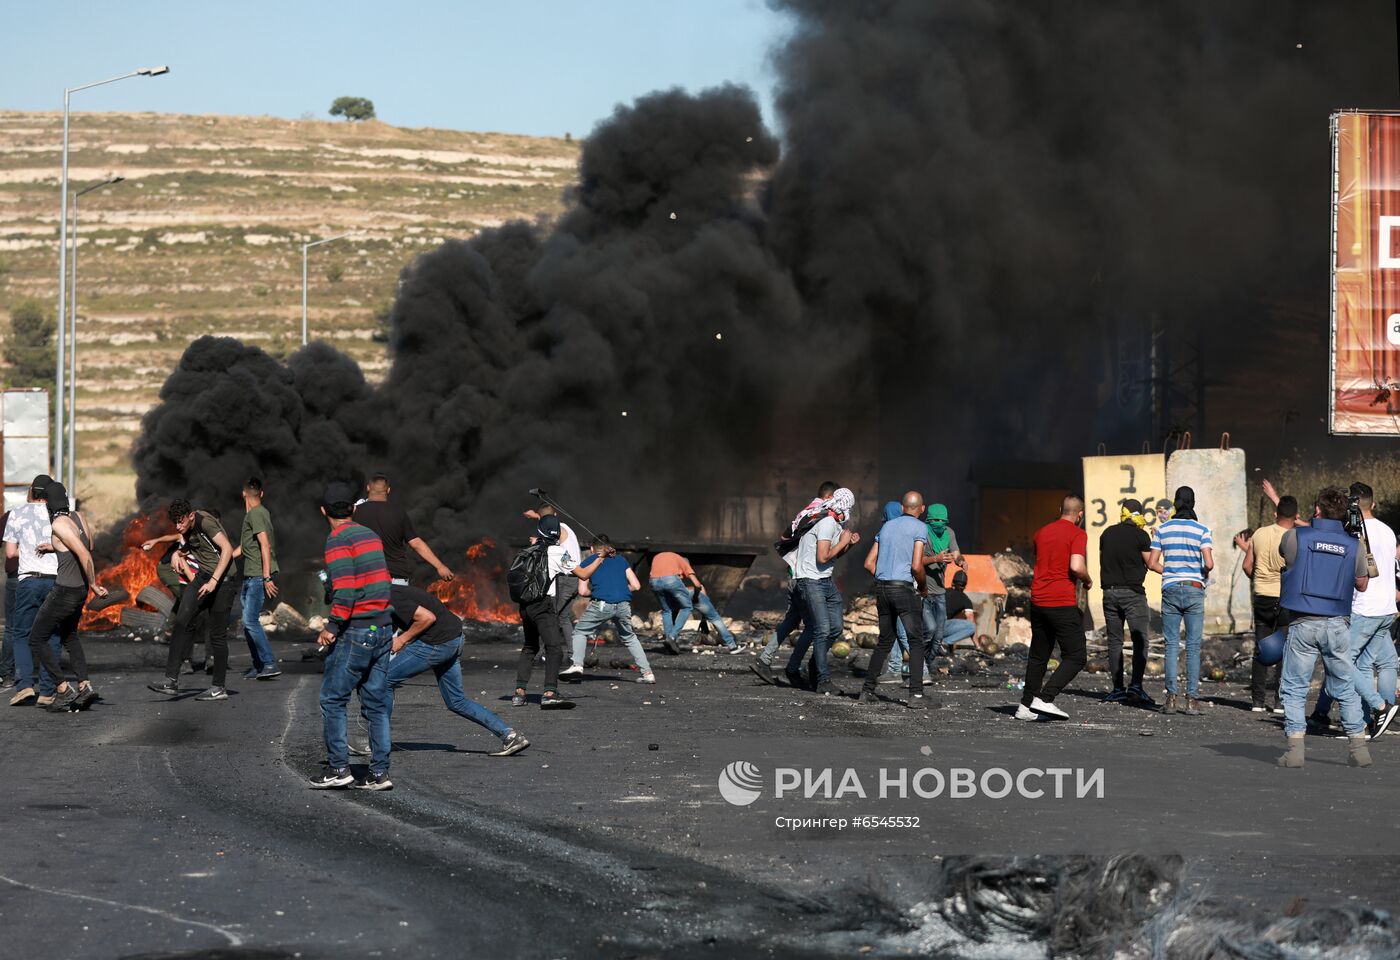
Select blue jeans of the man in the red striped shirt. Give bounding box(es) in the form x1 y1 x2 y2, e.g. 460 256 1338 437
321 627 393 775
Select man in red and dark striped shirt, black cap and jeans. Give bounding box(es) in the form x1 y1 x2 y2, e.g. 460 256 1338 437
311 483 393 791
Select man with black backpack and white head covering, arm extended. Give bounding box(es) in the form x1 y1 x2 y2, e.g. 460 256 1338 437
505 515 602 710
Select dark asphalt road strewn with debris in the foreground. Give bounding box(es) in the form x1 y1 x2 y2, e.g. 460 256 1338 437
0 632 1400 957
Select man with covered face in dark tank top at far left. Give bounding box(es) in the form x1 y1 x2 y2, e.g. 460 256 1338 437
29 483 106 712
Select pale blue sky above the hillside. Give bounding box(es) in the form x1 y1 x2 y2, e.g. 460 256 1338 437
0 0 790 137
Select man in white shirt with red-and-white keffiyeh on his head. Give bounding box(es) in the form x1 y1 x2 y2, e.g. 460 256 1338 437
784 487 861 694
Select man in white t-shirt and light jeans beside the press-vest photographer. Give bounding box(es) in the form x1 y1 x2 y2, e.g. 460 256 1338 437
1313 480 1400 739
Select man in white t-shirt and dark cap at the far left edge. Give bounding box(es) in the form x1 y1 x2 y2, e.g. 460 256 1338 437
4 473 62 707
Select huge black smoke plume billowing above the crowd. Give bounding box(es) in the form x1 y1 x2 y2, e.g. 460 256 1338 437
128 0 1396 570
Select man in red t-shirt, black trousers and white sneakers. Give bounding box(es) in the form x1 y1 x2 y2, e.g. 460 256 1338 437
1016 494 1093 721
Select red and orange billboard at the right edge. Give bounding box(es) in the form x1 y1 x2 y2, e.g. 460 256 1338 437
1327 111 1400 435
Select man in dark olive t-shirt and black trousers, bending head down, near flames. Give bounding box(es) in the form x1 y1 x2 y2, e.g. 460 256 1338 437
147 500 234 701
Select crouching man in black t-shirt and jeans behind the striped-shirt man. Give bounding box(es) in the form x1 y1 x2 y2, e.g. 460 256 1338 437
389 585 529 757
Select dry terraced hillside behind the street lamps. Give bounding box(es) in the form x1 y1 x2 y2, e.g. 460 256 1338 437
0 112 577 526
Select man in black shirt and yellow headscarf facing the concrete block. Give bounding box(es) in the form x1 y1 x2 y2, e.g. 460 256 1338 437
1099 500 1154 707
